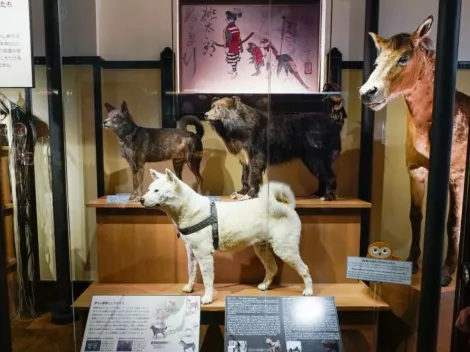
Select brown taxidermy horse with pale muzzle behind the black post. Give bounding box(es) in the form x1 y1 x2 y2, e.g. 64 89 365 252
359 16 470 286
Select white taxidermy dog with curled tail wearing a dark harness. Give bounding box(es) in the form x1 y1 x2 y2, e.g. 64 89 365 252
140 169 313 304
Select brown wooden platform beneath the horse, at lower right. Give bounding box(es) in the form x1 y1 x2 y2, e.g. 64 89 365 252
371 274 455 352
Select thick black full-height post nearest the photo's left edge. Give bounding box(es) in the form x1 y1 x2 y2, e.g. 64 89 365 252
44 0 73 324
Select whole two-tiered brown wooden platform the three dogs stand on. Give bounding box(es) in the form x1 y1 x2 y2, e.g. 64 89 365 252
83 197 382 352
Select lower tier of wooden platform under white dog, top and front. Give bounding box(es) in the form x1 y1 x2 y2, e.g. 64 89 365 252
74 282 389 352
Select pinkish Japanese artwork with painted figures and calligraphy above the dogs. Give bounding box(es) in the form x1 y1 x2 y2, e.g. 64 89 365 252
179 4 320 94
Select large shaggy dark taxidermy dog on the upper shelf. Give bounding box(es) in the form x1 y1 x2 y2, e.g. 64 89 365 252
205 84 346 200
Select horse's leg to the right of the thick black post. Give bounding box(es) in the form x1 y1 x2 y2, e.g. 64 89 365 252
441 171 464 286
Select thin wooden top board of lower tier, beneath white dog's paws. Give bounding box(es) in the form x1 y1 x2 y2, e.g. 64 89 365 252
74 282 389 312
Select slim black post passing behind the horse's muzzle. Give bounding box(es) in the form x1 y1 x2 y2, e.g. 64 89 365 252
358 0 379 257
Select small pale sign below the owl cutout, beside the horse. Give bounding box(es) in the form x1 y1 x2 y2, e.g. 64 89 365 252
346 257 411 285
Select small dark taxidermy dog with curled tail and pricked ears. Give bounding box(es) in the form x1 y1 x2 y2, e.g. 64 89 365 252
103 101 204 201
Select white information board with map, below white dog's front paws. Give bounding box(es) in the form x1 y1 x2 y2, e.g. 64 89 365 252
80 296 201 352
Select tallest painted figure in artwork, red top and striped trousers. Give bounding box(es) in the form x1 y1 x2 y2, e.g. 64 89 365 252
222 9 243 79
